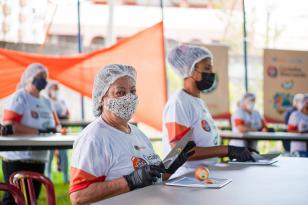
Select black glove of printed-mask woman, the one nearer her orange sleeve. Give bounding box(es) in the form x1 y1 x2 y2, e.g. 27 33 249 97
124 165 165 190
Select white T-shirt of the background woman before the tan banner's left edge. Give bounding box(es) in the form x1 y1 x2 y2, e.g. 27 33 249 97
230 107 264 148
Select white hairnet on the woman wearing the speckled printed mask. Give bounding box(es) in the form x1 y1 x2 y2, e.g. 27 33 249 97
92 64 136 117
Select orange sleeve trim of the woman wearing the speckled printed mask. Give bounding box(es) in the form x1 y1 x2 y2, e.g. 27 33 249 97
69 167 106 194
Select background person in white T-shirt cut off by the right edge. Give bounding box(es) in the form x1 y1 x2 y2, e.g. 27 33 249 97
288 94 308 156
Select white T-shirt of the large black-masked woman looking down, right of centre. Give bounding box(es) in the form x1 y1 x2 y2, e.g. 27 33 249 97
163 90 220 178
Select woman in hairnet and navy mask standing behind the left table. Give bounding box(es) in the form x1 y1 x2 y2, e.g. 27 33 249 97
0 63 57 204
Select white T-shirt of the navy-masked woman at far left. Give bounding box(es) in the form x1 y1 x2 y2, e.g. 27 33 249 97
0 89 55 162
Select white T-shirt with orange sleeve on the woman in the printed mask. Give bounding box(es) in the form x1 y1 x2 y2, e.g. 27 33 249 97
70 117 161 193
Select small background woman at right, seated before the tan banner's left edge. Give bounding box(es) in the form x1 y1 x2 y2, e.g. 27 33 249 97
230 93 267 149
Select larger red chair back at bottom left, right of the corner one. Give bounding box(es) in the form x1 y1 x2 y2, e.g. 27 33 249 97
10 171 56 205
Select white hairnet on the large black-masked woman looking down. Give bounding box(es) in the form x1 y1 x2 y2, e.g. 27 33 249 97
168 45 213 78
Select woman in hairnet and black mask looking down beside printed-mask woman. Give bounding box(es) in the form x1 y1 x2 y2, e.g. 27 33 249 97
163 45 253 177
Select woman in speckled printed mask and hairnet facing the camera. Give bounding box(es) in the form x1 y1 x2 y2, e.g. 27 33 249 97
70 64 193 204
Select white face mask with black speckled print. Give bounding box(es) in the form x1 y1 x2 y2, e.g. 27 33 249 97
104 93 138 120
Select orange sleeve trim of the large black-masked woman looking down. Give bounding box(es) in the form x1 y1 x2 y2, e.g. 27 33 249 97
166 122 191 142
